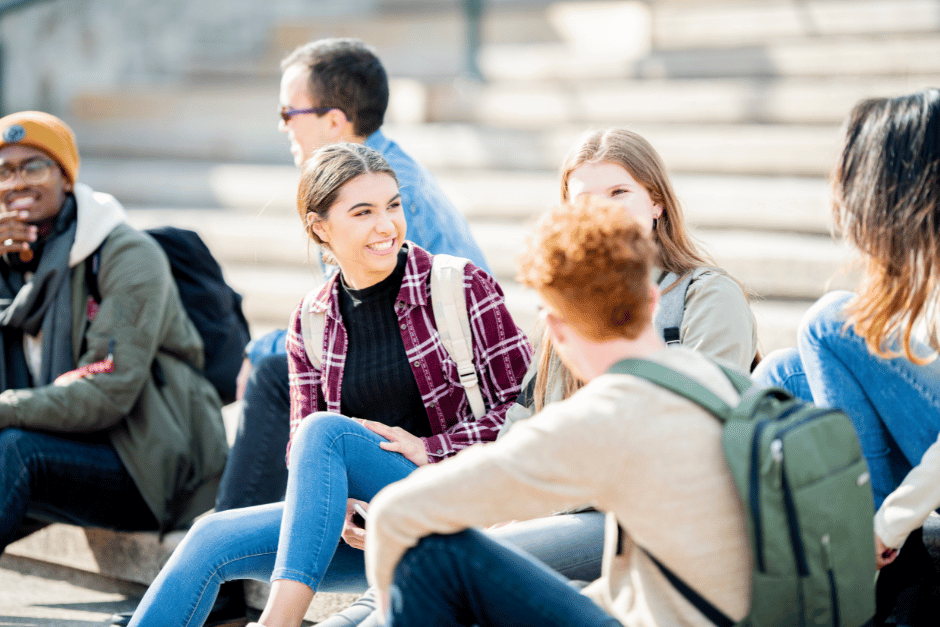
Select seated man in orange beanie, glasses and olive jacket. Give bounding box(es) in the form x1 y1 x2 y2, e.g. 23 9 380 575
0 111 228 552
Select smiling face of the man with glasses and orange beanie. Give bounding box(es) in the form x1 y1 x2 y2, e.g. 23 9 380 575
0 144 72 224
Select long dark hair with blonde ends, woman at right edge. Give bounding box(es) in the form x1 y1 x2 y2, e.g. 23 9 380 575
832 89 940 364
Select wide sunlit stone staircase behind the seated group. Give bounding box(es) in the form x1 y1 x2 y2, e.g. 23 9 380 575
10 0 940 620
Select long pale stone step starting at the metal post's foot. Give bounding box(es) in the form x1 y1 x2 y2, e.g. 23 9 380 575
470 75 940 129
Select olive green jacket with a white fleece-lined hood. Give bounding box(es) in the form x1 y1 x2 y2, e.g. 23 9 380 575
0 185 228 531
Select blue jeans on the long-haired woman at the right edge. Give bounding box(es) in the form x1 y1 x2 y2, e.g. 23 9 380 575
754 291 940 507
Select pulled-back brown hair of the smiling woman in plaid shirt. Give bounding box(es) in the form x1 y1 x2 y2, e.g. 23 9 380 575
297 142 398 262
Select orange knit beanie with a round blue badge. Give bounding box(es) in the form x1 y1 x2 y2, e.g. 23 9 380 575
0 111 80 183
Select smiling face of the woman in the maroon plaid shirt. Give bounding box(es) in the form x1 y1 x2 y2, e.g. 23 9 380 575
307 172 407 289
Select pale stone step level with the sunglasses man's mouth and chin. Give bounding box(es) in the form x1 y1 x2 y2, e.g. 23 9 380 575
75 103 839 175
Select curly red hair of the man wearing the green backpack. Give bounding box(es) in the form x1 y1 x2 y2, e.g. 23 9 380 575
517 197 656 341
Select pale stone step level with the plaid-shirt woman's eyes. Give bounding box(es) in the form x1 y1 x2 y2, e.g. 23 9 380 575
88 159 830 233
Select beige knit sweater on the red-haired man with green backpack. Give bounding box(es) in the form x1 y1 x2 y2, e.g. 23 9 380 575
366 348 750 627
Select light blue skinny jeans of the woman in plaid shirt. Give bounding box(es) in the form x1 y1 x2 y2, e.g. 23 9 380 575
130 412 415 627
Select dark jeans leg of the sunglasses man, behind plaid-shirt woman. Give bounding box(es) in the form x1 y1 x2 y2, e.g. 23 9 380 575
215 354 290 512
